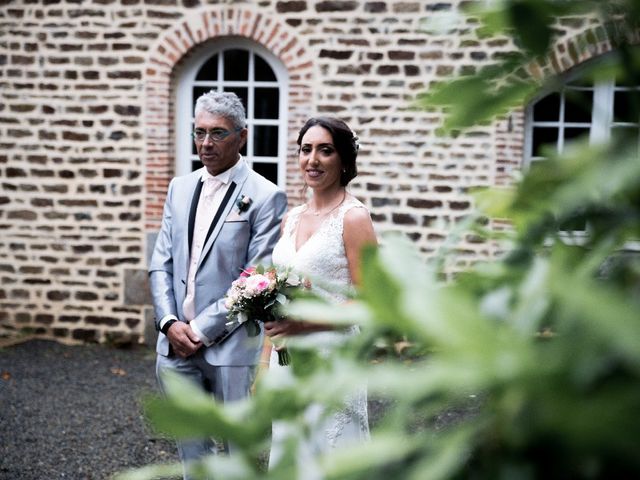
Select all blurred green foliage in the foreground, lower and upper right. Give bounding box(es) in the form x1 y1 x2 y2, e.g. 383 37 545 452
122 0 640 480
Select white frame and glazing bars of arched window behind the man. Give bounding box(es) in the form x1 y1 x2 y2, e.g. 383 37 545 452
175 37 289 189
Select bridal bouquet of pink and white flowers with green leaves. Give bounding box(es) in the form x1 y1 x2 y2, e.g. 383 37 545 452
225 266 302 365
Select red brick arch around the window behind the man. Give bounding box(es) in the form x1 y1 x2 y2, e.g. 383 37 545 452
144 7 313 232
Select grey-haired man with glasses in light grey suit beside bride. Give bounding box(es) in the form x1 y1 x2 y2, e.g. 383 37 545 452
149 91 287 479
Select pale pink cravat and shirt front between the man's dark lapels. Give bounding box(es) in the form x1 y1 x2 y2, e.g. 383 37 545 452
182 177 225 321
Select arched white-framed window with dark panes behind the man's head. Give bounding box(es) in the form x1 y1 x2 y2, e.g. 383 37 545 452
176 38 288 188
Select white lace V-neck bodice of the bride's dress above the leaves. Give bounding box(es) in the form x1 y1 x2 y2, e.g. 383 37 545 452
272 197 365 301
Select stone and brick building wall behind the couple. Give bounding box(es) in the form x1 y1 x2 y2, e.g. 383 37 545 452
0 0 609 342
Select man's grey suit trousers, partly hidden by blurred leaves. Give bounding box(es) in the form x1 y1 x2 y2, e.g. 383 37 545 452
156 348 256 480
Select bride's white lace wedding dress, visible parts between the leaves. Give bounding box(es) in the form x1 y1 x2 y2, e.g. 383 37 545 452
269 196 369 472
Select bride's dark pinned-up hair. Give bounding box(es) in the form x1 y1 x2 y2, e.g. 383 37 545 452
297 117 358 187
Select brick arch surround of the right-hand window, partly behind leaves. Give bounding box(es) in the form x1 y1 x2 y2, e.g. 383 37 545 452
494 25 640 185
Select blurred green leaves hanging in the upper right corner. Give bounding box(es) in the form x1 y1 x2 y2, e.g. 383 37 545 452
416 0 640 134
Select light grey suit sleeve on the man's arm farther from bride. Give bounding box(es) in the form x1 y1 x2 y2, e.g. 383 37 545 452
149 180 178 329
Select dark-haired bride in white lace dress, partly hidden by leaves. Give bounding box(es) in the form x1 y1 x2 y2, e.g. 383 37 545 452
265 117 376 468
